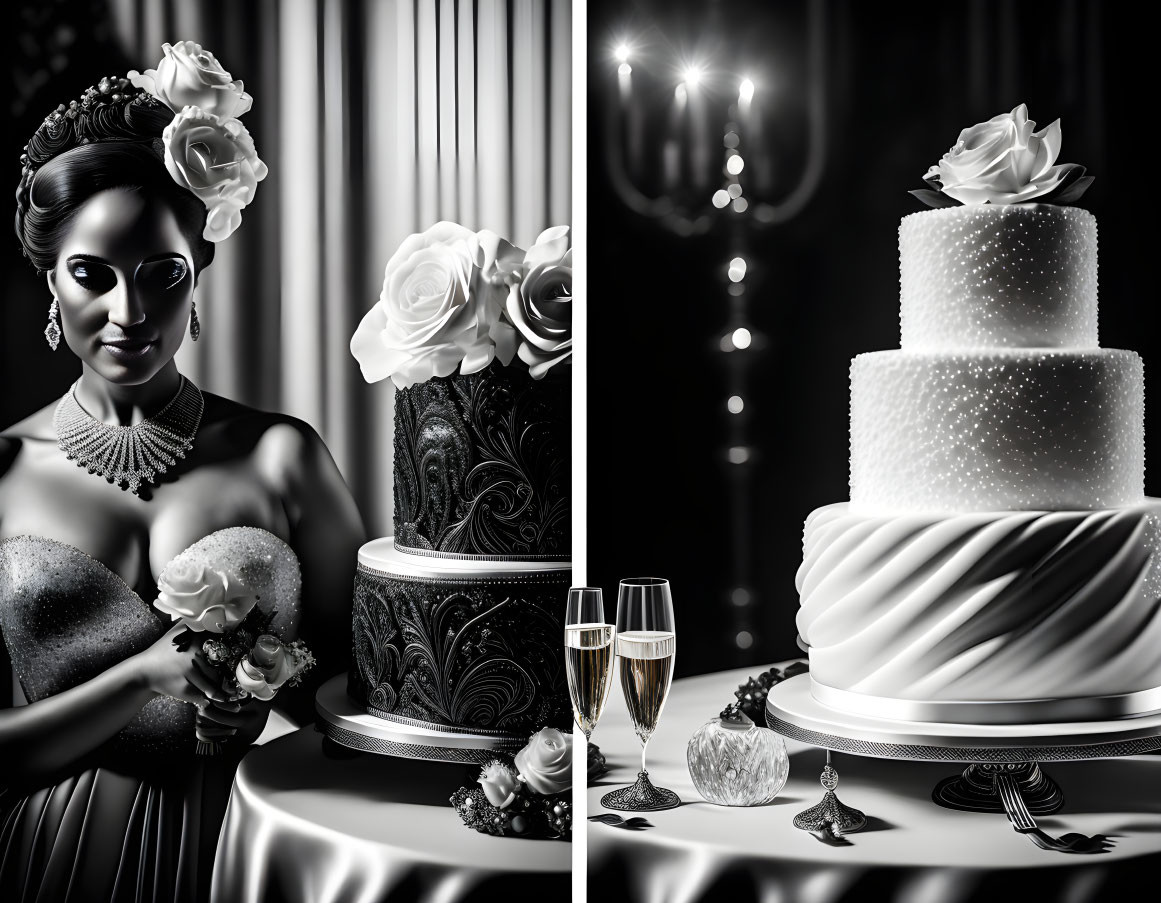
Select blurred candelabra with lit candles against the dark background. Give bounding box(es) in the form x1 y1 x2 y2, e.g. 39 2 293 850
604 0 828 652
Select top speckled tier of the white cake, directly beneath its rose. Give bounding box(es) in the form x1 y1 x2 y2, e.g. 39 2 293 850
899 204 1097 351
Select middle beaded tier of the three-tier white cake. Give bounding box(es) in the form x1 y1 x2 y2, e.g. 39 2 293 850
851 348 1145 513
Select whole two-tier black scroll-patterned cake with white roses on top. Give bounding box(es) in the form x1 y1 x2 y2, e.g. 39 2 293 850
332 224 571 760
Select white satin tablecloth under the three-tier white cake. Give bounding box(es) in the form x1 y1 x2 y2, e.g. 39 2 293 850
587 659 1161 903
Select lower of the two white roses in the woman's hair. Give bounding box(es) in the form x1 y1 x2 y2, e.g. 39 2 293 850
161 107 267 241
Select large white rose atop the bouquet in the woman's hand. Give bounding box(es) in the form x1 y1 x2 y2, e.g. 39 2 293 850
153 557 258 634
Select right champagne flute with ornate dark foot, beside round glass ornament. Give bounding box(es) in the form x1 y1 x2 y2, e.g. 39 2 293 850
600 577 682 812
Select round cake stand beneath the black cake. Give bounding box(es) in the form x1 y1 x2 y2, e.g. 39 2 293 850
315 674 528 765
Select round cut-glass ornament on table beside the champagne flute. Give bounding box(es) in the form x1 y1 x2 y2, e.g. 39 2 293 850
685 705 791 806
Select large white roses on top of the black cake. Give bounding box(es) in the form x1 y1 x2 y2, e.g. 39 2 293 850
351 222 572 389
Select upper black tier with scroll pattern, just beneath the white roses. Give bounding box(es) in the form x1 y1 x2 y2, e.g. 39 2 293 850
395 363 571 559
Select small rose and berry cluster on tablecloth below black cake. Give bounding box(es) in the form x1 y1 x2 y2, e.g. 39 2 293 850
450 728 572 840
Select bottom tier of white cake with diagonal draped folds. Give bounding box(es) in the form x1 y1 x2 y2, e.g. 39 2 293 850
796 499 1161 723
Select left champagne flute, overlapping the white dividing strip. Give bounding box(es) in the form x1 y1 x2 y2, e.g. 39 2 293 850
564 586 616 742
